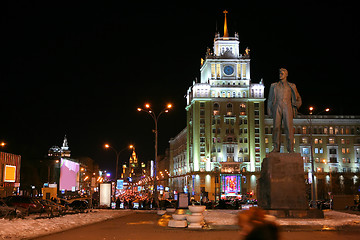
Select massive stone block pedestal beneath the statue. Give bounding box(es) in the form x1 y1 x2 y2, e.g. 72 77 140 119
258 153 308 210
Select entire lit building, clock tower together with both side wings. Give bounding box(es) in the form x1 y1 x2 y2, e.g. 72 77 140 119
169 12 360 200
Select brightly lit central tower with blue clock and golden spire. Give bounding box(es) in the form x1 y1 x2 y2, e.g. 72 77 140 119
186 11 265 200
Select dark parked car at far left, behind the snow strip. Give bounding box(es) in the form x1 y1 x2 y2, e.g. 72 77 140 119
5 196 44 213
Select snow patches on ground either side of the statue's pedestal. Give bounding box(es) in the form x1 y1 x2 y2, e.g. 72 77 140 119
204 210 360 227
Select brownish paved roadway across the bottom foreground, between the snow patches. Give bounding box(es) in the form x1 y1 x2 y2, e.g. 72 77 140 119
31 212 360 240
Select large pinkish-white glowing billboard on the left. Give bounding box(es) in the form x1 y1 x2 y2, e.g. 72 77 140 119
60 158 80 191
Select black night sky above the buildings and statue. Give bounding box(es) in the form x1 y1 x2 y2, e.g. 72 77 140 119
0 0 360 172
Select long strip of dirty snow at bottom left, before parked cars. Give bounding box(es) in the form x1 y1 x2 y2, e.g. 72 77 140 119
0 209 132 239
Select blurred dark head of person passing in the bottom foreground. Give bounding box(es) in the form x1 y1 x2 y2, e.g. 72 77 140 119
238 207 279 240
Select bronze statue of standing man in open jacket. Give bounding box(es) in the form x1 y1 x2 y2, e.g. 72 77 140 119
267 68 301 152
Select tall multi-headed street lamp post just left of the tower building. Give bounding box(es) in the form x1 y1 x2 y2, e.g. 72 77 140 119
137 103 172 207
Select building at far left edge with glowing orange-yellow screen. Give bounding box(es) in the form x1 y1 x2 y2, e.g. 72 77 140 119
0 152 21 197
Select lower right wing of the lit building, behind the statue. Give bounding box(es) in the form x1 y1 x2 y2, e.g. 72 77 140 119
264 115 360 199
